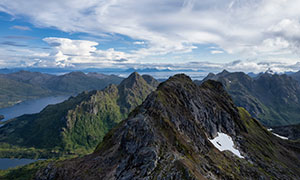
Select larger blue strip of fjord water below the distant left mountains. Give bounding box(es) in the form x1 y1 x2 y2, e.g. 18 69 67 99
0 96 69 121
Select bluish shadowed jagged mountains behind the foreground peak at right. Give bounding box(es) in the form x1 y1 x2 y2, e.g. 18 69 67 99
198 71 300 126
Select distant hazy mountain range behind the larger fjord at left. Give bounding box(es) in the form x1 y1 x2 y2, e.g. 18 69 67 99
0 71 123 108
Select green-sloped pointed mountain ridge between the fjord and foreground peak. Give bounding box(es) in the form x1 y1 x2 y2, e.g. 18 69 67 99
0 73 156 156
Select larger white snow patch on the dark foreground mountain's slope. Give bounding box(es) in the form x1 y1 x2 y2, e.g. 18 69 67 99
208 132 244 158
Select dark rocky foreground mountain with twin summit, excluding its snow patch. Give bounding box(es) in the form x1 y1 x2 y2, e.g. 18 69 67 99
36 74 300 180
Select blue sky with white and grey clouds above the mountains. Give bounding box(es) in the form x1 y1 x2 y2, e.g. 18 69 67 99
0 0 300 72
